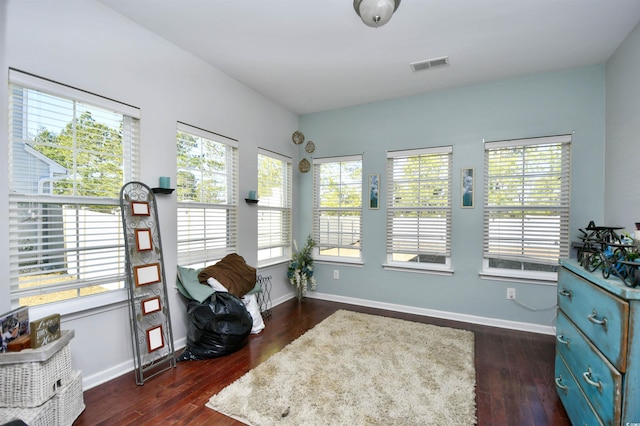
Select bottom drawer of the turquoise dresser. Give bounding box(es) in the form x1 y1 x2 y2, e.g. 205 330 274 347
555 352 603 426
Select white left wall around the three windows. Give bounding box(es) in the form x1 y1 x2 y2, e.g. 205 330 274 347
0 0 298 388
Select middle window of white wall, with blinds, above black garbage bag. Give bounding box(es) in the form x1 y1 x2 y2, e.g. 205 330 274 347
176 123 238 266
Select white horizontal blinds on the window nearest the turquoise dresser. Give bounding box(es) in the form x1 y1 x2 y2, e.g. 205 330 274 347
484 135 571 265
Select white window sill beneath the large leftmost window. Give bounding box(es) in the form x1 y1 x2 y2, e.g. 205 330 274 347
29 289 129 320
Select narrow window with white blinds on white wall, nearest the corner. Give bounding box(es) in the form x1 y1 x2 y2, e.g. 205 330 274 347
258 149 291 266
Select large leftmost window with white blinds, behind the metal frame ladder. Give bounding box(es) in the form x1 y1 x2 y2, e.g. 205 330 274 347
7 70 140 306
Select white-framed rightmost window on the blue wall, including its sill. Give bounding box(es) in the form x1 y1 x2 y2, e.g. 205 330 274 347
480 135 572 285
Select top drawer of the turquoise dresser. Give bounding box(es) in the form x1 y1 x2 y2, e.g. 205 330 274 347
558 268 629 372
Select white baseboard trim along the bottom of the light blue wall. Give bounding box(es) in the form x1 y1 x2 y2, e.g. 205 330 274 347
306 292 556 336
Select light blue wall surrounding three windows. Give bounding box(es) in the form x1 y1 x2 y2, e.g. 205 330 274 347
296 65 605 326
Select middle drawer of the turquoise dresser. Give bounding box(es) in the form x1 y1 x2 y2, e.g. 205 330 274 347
556 311 622 424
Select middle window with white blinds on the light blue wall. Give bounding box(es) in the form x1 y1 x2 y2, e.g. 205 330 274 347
387 146 452 269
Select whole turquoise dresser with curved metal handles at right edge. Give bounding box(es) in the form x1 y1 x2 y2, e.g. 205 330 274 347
555 259 640 426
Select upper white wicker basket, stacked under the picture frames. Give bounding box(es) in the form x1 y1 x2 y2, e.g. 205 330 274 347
0 331 73 408
